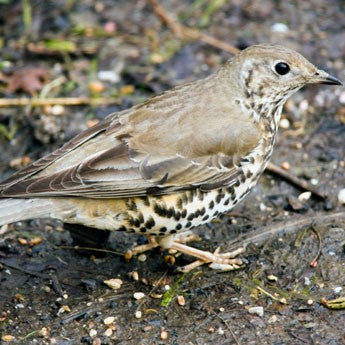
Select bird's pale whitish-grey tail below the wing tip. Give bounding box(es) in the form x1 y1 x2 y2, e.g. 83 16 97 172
0 198 54 226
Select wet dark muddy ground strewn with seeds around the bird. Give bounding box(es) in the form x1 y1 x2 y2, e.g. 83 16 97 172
0 0 345 345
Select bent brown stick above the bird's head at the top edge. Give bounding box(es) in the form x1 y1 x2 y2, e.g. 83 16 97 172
150 0 240 54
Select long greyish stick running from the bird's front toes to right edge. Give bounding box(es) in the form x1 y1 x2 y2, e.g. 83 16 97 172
229 212 345 250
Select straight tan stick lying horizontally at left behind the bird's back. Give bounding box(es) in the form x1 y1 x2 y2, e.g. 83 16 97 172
0 97 119 107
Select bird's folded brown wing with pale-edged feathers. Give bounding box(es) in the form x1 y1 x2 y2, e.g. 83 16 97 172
0 75 260 198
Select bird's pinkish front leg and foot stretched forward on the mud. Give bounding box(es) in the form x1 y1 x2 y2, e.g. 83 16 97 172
158 235 244 272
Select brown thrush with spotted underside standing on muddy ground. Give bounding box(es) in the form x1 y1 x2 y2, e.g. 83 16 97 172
0 44 342 271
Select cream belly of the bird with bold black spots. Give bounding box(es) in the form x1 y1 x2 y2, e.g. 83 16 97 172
56 165 259 236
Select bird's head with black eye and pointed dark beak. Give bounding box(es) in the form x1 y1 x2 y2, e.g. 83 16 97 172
231 44 342 103
